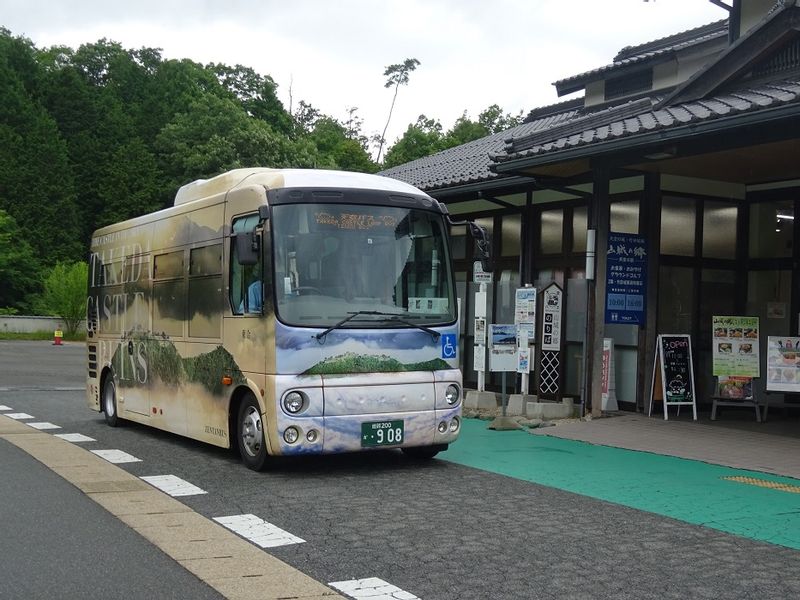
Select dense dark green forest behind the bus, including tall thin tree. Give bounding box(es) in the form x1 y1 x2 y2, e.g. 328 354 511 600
0 27 514 316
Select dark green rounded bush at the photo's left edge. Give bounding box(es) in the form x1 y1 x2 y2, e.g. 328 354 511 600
0 209 39 312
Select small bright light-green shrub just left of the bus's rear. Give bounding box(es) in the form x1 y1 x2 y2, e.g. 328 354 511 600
41 262 89 335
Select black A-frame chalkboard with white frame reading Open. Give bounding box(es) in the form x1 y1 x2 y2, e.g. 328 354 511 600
648 334 697 421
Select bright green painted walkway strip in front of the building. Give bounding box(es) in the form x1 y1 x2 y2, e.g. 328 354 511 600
441 419 800 550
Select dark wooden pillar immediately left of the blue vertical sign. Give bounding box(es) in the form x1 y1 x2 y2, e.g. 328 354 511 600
586 165 611 417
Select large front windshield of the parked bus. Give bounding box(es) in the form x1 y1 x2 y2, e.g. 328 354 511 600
270 203 456 328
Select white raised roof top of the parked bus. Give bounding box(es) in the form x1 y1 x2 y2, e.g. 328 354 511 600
175 167 427 206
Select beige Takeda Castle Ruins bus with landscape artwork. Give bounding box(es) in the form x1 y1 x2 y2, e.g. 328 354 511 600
86 168 489 470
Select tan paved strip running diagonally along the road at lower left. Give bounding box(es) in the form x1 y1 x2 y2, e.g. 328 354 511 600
0 415 343 600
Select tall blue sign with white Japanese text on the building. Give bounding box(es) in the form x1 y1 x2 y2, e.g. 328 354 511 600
606 233 647 325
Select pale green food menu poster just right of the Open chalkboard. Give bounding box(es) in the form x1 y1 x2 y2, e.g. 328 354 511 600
711 316 761 377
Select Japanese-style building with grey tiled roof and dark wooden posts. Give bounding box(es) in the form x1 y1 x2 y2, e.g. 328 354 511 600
382 0 800 414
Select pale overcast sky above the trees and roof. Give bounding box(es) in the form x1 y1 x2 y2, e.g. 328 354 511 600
0 0 727 155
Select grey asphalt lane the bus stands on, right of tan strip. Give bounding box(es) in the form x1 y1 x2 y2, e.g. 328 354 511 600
0 342 800 600
